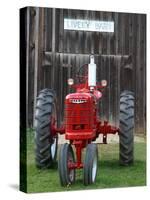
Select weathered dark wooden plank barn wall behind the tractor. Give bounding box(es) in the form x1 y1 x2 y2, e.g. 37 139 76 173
27 8 146 133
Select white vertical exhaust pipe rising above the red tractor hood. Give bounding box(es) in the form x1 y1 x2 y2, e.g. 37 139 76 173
88 55 96 90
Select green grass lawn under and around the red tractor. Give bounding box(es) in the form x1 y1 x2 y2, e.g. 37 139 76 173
27 132 146 193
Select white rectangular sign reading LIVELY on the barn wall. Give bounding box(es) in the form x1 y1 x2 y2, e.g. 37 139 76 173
64 19 114 33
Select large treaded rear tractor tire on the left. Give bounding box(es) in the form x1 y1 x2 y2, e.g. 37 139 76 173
34 89 58 168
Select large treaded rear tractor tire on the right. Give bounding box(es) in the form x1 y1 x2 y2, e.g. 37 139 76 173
119 91 134 166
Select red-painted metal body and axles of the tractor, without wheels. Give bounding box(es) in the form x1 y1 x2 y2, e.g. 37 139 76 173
51 74 119 170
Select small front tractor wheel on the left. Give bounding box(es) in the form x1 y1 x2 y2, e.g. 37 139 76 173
58 143 75 186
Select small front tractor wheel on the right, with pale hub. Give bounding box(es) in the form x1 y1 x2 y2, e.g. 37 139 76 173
83 144 98 185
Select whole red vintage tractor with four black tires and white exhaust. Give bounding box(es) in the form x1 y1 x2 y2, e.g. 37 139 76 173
35 55 134 186
